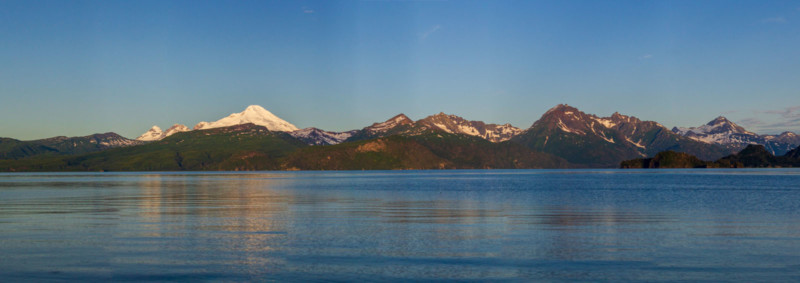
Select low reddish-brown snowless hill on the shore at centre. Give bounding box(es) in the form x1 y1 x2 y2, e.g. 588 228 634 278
285 132 569 170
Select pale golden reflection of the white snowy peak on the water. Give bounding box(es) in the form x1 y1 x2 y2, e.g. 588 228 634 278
127 175 293 270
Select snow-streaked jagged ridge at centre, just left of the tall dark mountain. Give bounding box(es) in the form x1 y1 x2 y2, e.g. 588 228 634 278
415 113 522 142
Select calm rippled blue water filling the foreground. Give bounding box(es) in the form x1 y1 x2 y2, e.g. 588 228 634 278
0 169 800 282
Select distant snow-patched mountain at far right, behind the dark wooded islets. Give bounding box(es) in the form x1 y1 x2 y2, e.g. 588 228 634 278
672 116 800 155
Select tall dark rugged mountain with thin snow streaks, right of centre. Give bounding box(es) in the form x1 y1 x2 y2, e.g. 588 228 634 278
511 104 731 167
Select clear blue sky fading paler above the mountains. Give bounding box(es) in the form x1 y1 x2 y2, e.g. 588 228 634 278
0 0 800 140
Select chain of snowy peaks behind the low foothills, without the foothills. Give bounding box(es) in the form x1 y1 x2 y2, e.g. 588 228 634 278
117 104 800 167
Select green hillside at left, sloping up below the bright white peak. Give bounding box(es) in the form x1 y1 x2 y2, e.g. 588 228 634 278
0 124 305 171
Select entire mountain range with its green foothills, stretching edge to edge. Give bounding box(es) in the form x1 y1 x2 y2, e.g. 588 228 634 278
0 104 800 171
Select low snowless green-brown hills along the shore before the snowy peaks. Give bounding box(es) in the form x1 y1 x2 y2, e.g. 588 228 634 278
0 124 569 171
